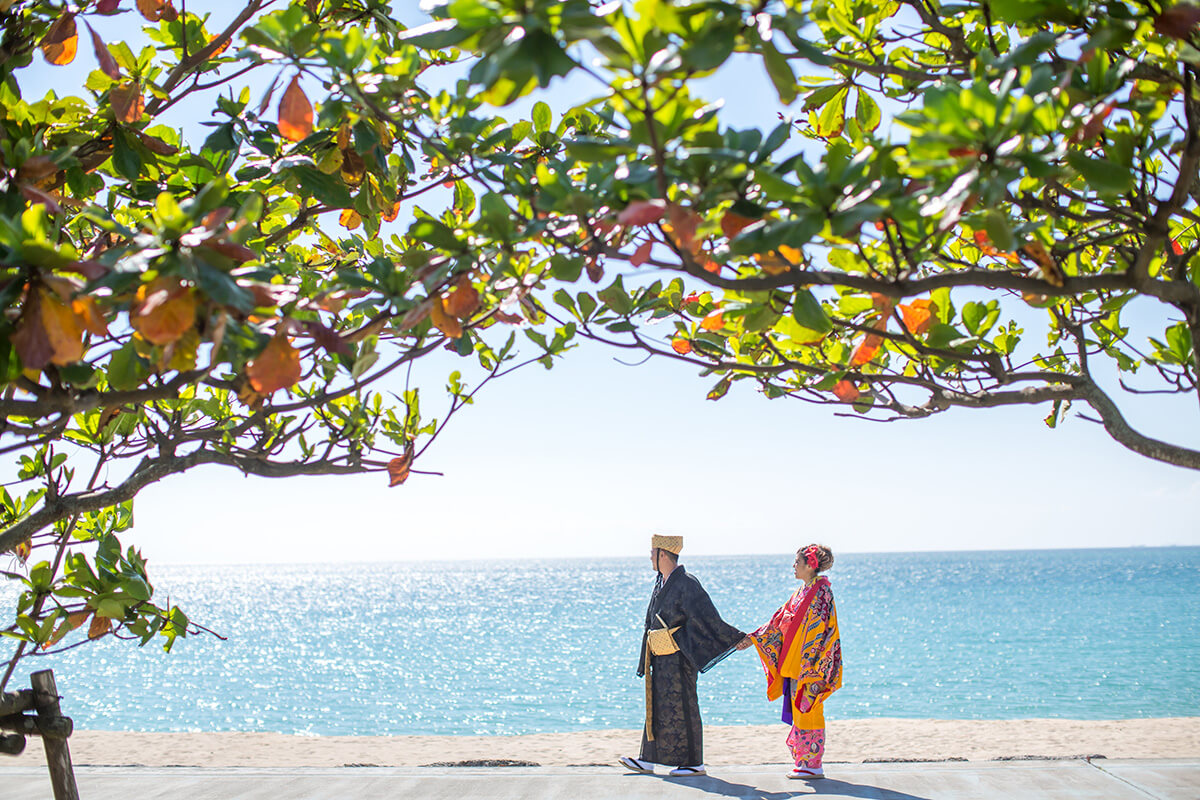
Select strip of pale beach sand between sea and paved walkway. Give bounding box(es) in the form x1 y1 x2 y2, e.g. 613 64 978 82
0 717 1200 768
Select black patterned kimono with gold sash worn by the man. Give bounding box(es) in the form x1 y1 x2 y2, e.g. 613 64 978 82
637 566 745 766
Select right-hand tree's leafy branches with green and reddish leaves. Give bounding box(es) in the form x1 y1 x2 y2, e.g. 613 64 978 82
409 0 1200 469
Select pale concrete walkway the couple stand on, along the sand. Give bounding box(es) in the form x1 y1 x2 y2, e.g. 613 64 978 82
0 758 1200 800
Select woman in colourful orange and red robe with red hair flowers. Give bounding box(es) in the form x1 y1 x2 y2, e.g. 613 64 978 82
738 545 841 778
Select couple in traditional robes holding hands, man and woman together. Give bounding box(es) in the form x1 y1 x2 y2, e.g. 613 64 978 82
620 535 841 780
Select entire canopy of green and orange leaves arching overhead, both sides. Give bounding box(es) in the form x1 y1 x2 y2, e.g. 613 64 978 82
0 0 1200 682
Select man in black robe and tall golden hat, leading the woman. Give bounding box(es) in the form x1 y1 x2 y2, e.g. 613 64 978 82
620 535 745 777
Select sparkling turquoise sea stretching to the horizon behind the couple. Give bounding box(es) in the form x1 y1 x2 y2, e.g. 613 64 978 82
0 547 1200 735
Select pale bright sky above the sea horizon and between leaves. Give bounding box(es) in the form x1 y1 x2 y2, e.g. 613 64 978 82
11 3 1200 563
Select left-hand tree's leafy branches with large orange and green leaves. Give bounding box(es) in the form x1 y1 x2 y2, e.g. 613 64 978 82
0 0 560 685
